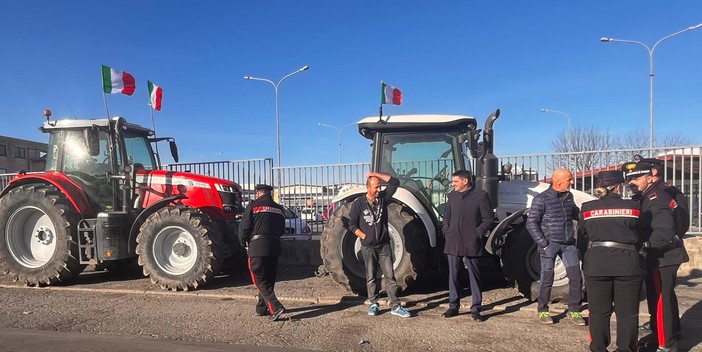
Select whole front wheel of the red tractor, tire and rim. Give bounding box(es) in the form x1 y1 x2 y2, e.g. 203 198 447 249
136 206 222 291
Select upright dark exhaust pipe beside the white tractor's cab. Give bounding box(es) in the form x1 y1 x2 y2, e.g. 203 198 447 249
475 109 500 208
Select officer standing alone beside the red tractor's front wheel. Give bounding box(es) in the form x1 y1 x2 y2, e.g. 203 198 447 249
239 185 285 321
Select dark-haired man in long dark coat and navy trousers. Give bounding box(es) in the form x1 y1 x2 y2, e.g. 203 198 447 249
442 170 495 321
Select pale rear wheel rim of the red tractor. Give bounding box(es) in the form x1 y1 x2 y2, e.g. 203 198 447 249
5 206 56 269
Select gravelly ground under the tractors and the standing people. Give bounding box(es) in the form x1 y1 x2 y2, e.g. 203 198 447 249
0 268 702 351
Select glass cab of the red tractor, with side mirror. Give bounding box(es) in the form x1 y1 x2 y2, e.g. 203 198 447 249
41 117 177 213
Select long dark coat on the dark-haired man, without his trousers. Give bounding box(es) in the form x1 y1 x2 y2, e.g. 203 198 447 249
442 188 495 257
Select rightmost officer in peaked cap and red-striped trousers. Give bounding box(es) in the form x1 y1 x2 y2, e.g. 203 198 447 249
622 160 690 351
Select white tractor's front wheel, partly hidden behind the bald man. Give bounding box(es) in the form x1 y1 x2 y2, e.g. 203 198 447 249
501 222 568 302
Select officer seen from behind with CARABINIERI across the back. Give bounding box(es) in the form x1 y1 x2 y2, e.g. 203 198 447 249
578 170 643 351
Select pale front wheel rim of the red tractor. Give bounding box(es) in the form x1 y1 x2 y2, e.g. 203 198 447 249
152 226 197 275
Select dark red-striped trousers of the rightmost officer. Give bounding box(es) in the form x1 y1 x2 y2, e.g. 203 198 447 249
645 264 680 347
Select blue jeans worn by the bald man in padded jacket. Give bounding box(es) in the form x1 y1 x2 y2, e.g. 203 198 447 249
537 242 583 312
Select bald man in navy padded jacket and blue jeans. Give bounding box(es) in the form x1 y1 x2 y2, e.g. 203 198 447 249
526 169 586 326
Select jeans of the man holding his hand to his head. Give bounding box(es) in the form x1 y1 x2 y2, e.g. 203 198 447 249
361 243 400 308
